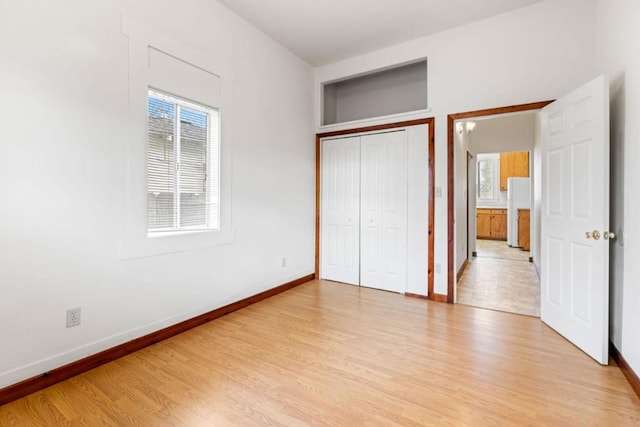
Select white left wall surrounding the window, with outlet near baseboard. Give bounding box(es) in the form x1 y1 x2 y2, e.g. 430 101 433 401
0 0 315 387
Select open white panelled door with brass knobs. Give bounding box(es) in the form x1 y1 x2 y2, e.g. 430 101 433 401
540 76 609 365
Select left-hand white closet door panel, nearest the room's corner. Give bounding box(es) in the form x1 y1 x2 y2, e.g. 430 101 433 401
320 137 360 285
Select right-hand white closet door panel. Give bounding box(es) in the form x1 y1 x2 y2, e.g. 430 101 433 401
360 130 408 293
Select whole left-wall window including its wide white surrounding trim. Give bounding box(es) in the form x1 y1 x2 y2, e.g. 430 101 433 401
119 24 236 260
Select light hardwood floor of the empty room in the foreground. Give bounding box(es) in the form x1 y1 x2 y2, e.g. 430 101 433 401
0 281 640 426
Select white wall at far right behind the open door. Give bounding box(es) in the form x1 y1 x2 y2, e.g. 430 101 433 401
597 0 640 374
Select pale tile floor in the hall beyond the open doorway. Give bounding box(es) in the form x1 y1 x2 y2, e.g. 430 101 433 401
457 239 540 317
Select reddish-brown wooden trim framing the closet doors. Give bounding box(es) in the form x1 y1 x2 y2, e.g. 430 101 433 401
315 117 435 300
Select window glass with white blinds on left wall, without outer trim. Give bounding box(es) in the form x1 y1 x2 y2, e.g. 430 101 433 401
147 89 220 235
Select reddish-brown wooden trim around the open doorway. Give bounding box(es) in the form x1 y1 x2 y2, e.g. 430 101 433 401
447 101 553 304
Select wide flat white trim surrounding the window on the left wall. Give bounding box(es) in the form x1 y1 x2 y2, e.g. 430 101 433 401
120 16 235 260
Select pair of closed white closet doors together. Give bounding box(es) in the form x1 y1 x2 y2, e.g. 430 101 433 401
320 129 410 292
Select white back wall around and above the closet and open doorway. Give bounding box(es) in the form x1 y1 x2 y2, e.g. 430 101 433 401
314 0 597 294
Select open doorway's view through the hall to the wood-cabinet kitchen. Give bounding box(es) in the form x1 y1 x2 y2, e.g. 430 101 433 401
456 148 540 317
